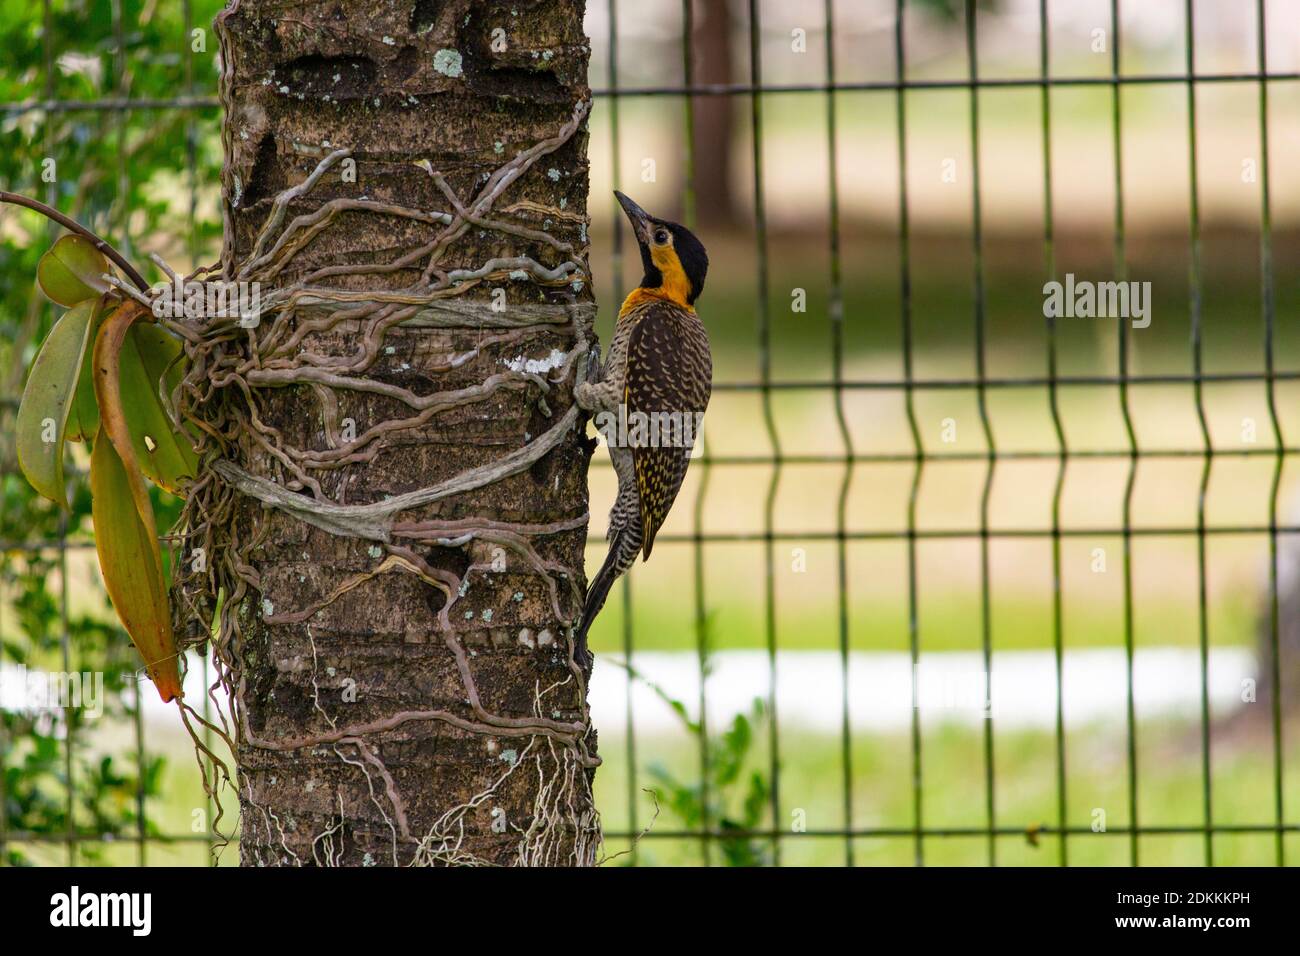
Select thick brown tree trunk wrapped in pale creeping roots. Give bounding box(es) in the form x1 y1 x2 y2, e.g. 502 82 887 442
200 0 598 865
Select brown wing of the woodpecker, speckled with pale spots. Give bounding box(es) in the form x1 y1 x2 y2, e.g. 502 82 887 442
623 302 714 558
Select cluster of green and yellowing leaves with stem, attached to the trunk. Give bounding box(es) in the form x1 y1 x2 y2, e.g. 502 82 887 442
0 193 198 702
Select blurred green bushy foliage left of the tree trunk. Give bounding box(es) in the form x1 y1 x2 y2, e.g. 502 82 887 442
0 0 221 865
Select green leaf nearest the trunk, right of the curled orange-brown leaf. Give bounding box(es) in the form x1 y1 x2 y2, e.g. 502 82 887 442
118 323 199 494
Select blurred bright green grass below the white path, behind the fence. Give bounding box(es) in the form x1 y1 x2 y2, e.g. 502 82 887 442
17 722 1300 866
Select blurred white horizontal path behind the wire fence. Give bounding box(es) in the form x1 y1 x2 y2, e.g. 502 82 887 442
0 648 1256 736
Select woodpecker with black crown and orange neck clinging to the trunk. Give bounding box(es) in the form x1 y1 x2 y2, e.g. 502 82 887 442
575 191 714 666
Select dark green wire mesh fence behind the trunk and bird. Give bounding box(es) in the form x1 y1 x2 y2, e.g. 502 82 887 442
0 0 1300 865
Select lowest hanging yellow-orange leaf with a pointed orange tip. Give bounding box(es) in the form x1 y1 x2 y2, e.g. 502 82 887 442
90 429 182 704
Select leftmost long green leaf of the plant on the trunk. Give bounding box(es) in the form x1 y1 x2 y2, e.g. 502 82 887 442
16 299 99 507
